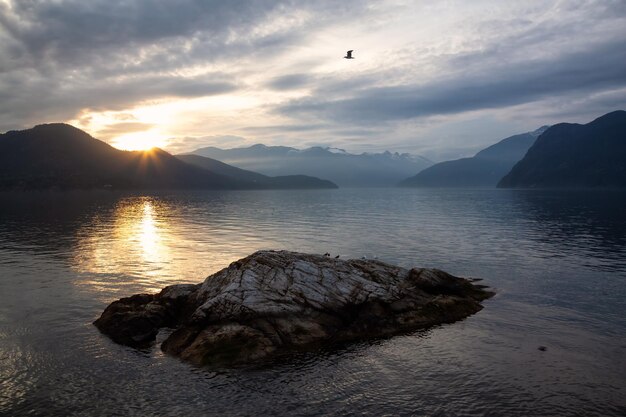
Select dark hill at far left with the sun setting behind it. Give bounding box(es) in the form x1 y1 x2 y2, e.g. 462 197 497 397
0 123 336 189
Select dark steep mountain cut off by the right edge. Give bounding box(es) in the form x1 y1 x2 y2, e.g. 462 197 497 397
498 110 626 188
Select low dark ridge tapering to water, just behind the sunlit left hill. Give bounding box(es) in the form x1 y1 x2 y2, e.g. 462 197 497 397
176 155 337 189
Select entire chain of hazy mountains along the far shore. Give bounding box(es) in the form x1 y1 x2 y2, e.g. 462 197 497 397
0 110 626 189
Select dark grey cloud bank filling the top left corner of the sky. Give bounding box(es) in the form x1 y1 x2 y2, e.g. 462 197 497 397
0 0 280 65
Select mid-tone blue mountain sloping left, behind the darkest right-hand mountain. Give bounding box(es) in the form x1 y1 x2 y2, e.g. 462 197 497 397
399 126 547 187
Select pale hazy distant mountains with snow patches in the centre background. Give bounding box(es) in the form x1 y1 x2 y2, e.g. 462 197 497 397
192 144 432 187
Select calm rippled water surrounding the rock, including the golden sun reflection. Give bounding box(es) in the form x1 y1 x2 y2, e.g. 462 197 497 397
0 189 626 416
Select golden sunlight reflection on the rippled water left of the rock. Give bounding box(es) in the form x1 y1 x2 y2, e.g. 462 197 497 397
72 196 263 295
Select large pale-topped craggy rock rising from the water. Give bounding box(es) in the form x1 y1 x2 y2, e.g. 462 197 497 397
94 251 493 365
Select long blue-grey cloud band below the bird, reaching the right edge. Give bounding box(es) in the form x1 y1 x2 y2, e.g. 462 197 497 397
277 41 626 124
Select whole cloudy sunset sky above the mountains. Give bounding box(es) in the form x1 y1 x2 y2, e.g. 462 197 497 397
0 0 626 161
